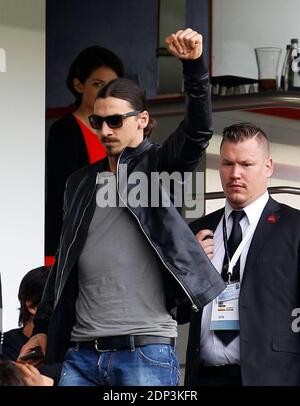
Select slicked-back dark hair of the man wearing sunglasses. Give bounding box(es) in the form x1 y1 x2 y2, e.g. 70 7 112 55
96 78 156 137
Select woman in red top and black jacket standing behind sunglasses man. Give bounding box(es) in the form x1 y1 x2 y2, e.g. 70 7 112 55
45 46 124 265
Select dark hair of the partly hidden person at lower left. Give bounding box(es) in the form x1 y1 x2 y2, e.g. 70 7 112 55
18 266 49 326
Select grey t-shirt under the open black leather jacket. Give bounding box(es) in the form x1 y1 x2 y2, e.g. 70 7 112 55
71 174 177 341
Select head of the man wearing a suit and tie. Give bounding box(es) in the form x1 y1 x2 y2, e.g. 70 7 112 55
220 123 273 209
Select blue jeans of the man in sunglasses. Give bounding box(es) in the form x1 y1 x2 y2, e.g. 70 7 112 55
59 344 180 386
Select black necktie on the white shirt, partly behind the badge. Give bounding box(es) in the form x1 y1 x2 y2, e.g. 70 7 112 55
215 210 245 345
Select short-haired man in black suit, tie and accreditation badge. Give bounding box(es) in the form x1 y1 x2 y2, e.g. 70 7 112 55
185 123 300 386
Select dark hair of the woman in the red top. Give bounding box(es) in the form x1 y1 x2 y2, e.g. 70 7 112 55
67 46 124 106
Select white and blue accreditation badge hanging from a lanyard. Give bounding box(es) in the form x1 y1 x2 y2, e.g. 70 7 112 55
210 282 240 330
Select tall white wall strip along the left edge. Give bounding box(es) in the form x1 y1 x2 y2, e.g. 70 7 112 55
0 0 45 330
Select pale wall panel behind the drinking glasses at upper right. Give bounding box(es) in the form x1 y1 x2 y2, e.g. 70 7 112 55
212 0 300 79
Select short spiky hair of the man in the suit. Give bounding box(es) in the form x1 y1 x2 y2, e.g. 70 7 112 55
220 123 269 152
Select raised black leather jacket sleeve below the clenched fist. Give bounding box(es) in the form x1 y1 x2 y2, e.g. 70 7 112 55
158 57 213 173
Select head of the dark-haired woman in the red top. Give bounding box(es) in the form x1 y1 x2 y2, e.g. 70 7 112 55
67 46 124 110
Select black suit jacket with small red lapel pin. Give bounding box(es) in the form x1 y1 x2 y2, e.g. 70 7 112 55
185 198 300 385
